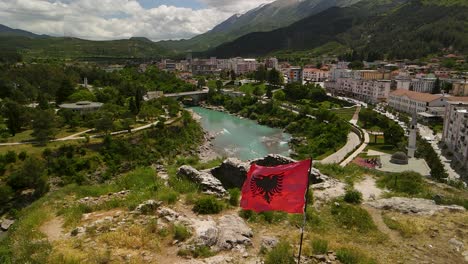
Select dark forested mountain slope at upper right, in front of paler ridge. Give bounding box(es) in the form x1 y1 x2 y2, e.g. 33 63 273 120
206 0 468 59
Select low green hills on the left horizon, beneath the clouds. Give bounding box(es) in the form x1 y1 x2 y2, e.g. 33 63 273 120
0 36 169 59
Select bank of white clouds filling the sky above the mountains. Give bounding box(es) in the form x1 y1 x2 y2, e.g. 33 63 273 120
0 0 272 41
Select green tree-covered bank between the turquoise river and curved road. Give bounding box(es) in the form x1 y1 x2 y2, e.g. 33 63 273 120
208 84 350 159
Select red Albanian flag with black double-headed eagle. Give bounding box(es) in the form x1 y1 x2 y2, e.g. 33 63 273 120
241 160 311 214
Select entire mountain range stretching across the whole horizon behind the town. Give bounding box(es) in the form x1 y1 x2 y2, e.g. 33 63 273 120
0 0 468 59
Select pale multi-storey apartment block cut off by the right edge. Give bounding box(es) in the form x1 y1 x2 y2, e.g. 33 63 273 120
442 100 468 168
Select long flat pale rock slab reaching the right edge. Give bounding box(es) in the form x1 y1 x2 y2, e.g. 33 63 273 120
365 197 465 215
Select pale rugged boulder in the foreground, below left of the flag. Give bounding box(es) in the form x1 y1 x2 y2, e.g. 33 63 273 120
217 215 253 250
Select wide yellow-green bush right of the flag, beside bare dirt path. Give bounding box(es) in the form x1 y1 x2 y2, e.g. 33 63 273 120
331 203 376 233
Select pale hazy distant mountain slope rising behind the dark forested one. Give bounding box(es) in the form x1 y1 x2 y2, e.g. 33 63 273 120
159 0 361 52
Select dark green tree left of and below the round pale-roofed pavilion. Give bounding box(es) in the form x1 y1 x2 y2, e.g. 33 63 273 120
32 110 57 143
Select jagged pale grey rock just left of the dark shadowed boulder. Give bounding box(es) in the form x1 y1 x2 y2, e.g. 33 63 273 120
177 165 227 196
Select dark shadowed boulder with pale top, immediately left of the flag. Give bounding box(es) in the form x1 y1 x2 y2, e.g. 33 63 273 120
211 158 250 189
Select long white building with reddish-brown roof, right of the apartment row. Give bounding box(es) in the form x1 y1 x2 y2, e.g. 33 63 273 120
388 89 447 114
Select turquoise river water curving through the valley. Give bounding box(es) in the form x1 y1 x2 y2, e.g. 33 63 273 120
190 107 291 161
